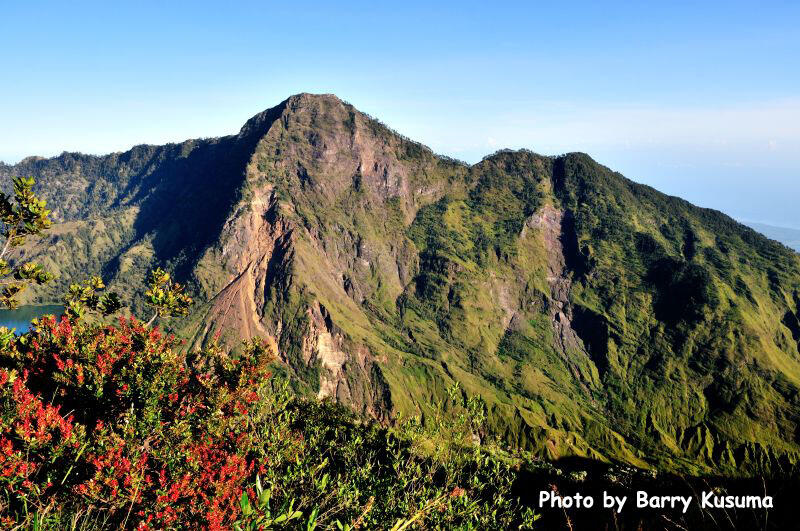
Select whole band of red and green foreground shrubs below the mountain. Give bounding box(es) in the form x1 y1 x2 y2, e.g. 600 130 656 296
0 317 533 530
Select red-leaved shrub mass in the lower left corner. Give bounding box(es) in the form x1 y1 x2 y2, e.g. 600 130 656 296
0 317 271 529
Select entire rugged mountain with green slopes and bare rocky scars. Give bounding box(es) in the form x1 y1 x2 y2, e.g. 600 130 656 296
0 94 800 476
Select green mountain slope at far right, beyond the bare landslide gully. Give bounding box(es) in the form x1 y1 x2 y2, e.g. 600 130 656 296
556 155 800 474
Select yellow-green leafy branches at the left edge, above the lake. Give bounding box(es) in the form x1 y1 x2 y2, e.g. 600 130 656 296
0 177 53 309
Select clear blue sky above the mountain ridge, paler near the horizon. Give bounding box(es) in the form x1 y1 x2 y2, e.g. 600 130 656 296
0 0 800 228
